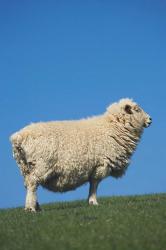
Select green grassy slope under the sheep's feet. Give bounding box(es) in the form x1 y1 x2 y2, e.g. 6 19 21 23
0 194 166 250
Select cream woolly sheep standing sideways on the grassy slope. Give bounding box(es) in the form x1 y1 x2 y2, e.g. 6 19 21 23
10 98 152 212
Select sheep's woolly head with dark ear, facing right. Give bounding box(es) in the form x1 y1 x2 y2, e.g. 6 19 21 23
107 98 152 132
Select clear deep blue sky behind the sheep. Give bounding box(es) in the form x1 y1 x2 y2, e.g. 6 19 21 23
0 0 166 208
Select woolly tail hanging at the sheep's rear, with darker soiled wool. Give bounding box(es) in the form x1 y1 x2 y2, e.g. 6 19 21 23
10 132 30 175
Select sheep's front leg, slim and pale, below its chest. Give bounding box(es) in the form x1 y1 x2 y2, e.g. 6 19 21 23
88 179 99 205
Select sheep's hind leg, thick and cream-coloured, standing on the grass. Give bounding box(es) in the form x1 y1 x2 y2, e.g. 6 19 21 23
25 175 40 212
